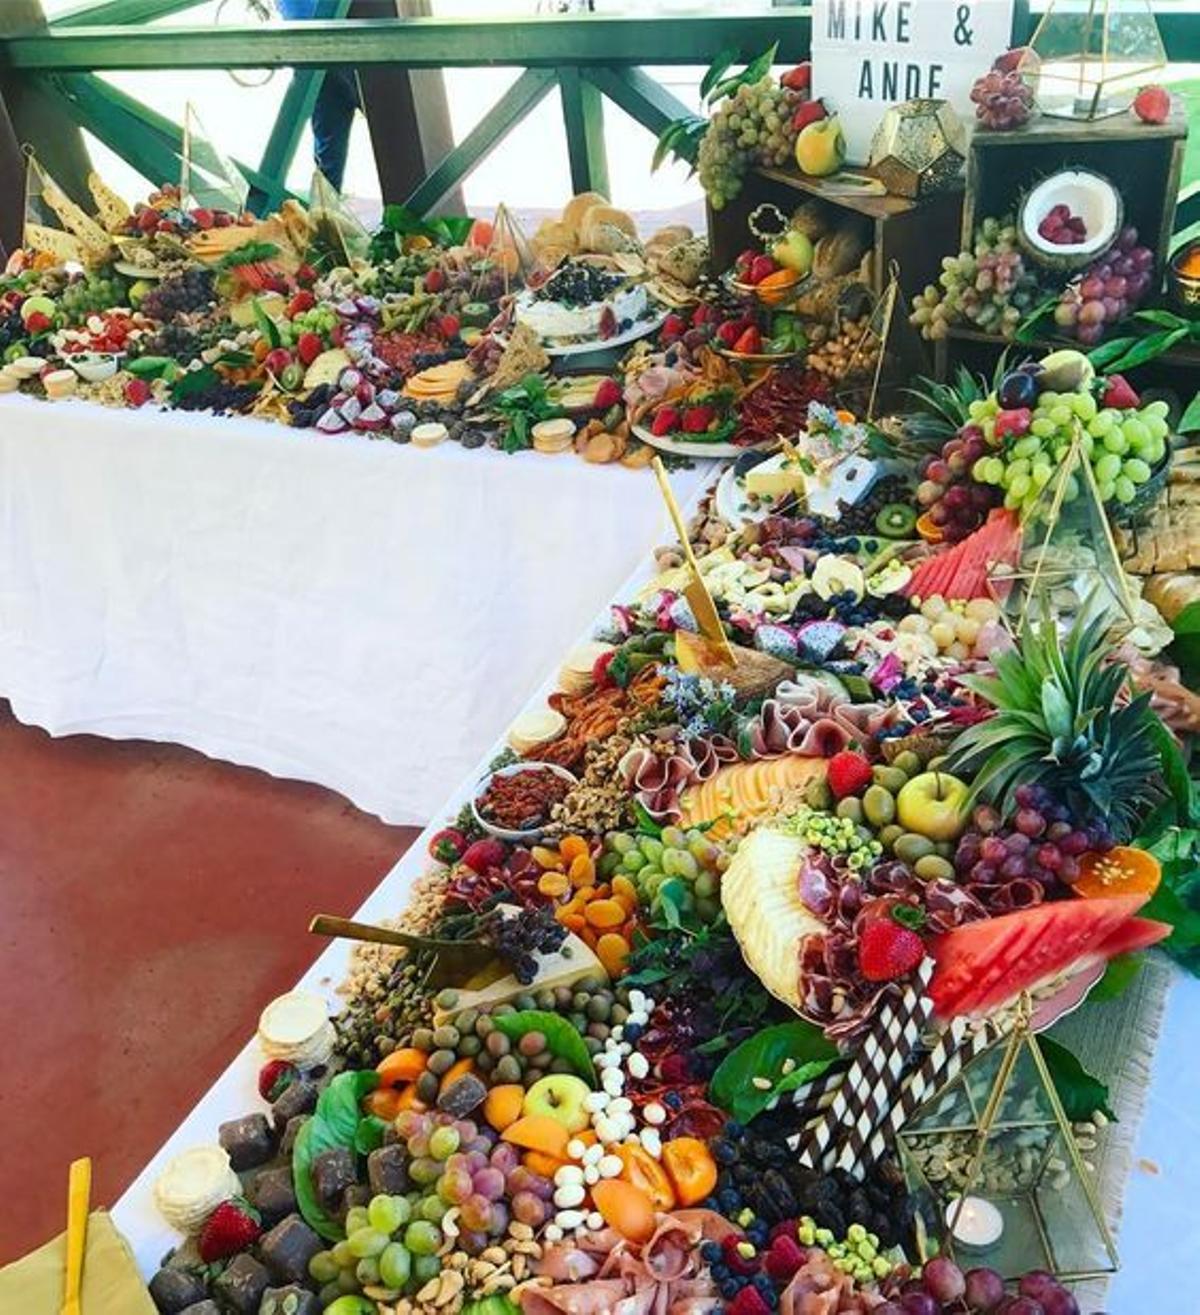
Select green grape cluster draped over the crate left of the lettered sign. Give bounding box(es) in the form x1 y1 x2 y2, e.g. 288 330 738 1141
697 76 807 210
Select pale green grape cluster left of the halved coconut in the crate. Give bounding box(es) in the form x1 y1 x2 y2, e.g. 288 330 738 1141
908 218 1038 338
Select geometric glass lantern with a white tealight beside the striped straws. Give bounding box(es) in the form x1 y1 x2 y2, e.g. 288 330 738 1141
896 1005 1119 1279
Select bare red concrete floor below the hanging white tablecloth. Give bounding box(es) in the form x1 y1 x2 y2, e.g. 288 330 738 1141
0 701 415 1262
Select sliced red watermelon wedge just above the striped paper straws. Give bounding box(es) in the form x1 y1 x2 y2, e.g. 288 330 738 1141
929 894 1171 1018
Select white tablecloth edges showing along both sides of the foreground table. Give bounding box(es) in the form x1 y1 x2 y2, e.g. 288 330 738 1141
105 486 1200 1315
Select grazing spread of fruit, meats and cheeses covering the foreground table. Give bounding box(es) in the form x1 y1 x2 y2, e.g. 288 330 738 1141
119 326 1200 1315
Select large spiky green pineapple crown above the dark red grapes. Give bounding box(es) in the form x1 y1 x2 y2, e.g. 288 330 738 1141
948 613 1165 842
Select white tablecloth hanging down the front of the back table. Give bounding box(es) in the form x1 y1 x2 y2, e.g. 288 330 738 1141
0 397 711 823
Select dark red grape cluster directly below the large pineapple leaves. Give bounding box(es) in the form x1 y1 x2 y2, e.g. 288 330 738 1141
954 785 1113 913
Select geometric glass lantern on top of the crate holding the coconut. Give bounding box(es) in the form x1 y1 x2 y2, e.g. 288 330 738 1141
1017 0 1167 120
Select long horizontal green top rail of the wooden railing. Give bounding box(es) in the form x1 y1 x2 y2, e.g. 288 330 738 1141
0 9 811 72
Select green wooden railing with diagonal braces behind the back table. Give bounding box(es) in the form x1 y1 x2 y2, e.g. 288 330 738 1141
0 0 1200 225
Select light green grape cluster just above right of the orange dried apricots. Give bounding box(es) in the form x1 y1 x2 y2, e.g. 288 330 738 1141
599 826 732 922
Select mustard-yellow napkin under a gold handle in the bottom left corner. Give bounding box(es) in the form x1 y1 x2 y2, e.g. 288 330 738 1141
0 1210 156 1315
